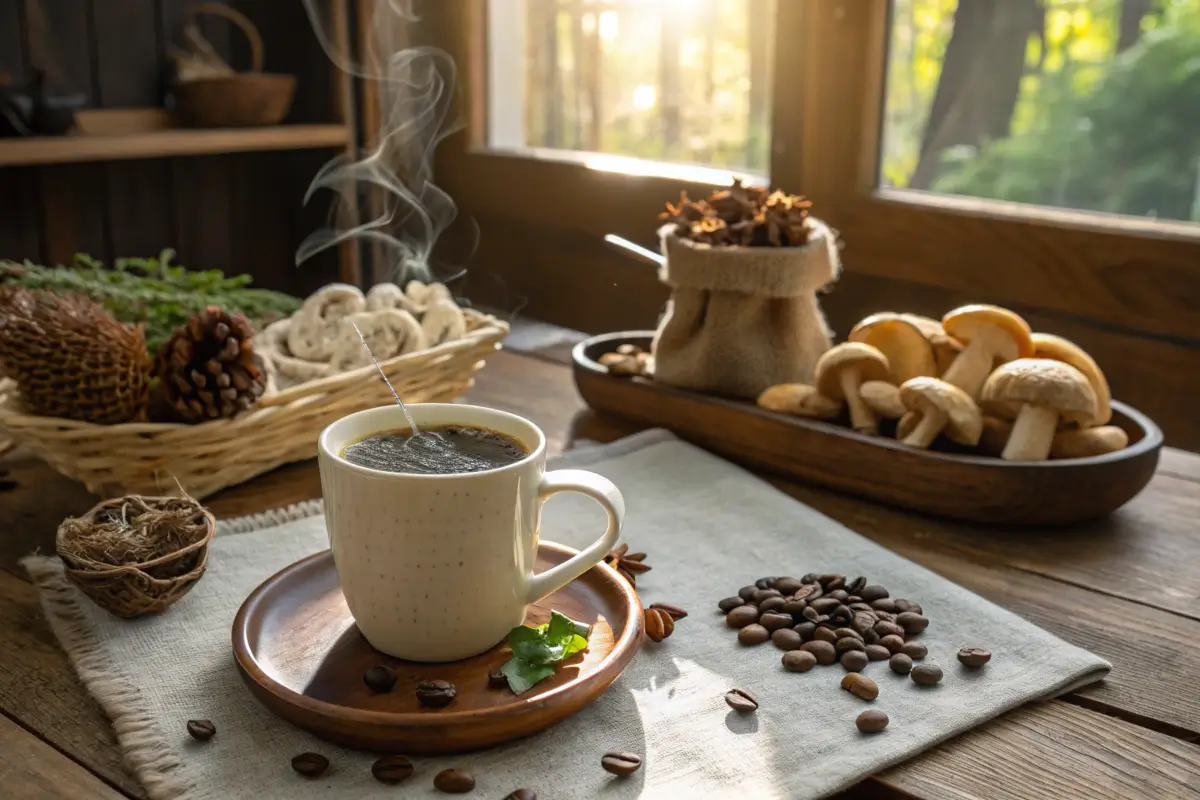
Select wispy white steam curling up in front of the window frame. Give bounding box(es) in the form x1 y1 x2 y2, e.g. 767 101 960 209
295 0 463 282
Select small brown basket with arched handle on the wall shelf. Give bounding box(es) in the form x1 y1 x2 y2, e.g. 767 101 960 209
170 2 296 128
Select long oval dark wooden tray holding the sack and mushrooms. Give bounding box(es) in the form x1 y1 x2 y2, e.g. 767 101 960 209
572 331 1163 525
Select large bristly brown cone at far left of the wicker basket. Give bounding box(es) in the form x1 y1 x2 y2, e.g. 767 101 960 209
0 287 150 425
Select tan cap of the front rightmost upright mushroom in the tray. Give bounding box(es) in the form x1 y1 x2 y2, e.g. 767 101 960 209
979 359 1097 422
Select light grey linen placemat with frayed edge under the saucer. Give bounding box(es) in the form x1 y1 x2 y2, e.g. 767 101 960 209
24 432 1109 800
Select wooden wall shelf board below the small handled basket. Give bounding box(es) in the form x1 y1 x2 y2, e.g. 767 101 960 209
0 125 350 167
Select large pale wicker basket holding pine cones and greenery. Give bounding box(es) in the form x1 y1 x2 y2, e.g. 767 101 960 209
0 309 509 499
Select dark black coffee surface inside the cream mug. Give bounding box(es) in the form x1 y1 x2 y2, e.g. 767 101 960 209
342 425 529 475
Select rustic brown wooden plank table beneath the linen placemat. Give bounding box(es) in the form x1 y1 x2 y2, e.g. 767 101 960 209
0 348 1200 800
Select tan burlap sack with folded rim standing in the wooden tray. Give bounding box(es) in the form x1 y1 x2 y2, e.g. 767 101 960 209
654 217 841 398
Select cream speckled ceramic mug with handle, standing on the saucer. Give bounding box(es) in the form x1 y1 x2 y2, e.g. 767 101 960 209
318 403 625 661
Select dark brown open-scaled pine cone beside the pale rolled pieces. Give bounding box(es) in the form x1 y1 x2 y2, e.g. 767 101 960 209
151 306 266 422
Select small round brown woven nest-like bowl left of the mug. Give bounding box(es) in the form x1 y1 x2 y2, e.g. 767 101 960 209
55 498 216 619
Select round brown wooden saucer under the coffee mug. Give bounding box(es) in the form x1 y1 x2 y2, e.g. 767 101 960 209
233 541 642 754
